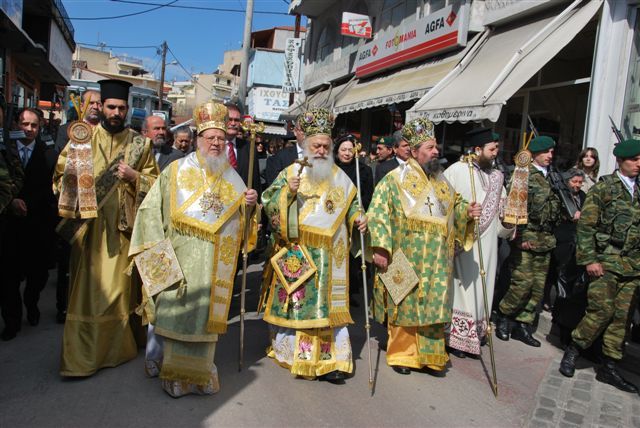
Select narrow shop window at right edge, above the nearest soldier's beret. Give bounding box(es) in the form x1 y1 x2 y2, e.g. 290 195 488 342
622 10 640 138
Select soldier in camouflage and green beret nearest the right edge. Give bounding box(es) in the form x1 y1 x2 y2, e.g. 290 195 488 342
560 140 640 392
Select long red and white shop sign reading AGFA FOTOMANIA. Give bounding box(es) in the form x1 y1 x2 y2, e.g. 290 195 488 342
354 3 469 77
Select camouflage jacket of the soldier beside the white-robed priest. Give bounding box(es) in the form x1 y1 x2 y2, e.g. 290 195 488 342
516 165 560 253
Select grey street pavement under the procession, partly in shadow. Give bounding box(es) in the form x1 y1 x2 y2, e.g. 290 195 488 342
0 265 640 427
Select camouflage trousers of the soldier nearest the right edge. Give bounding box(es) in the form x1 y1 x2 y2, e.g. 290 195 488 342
571 272 640 360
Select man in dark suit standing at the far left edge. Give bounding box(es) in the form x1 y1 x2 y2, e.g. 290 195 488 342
0 109 57 340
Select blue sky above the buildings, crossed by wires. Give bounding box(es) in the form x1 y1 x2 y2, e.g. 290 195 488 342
62 0 304 81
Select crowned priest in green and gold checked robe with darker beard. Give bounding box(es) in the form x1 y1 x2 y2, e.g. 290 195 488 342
367 119 481 375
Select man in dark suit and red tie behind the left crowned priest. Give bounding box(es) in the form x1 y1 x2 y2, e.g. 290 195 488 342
225 103 262 199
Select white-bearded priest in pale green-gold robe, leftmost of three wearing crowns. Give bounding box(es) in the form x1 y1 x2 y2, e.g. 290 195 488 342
129 102 258 397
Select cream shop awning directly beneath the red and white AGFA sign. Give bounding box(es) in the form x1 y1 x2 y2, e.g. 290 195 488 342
333 32 479 114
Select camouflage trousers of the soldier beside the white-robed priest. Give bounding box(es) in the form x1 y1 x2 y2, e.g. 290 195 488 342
500 246 551 324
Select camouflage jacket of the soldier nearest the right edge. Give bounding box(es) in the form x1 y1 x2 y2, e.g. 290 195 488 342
576 173 640 276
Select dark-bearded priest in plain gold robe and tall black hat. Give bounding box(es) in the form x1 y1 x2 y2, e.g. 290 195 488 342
54 80 158 376
